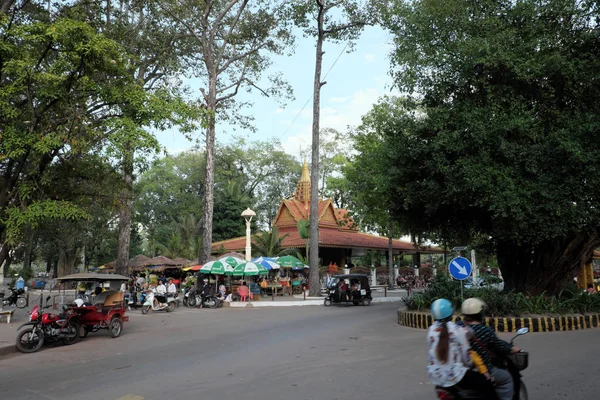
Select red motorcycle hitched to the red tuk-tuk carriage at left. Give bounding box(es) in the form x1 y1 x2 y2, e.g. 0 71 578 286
15 296 80 353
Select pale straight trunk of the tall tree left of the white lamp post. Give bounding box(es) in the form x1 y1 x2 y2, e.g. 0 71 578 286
199 78 218 264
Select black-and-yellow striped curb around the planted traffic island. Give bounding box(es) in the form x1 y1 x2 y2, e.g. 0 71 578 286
398 309 600 332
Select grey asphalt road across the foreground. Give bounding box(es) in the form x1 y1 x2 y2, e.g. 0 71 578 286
0 304 600 400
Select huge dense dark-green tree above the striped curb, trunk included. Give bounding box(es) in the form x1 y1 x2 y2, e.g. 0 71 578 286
384 0 600 293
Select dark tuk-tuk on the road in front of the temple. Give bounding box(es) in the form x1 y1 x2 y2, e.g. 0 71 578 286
324 274 373 306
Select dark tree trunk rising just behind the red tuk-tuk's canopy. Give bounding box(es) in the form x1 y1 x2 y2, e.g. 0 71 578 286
115 146 133 275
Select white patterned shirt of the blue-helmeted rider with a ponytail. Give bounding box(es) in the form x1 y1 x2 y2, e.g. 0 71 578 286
427 321 471 387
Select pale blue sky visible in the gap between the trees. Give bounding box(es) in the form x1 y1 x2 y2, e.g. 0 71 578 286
157 27 392 159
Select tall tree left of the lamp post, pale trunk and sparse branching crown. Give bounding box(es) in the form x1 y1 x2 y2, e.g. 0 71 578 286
155 0 293 262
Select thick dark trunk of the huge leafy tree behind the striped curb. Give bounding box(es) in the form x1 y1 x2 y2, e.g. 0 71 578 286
496 232 600 295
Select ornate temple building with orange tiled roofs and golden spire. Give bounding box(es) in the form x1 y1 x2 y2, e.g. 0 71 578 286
212 162 442 267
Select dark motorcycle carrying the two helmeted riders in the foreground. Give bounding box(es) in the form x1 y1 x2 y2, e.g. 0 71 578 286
435 328 529 400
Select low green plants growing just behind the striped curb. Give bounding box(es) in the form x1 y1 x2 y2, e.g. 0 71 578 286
403 277 600 317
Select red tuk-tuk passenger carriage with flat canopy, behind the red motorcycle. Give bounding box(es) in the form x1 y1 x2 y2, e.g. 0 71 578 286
57 273 129 338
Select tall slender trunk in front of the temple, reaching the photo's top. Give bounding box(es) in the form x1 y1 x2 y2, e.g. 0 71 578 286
309 4 324 297
